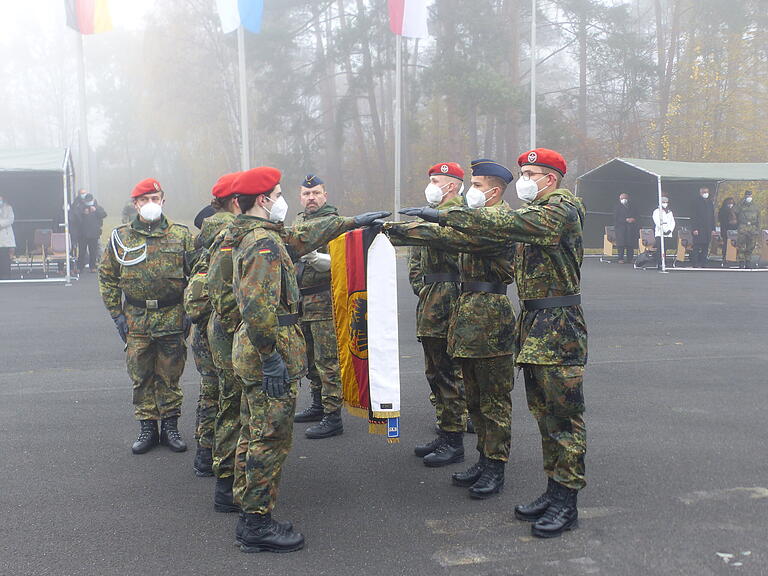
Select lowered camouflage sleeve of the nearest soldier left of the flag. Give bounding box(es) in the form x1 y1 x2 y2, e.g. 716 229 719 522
239 238 281 360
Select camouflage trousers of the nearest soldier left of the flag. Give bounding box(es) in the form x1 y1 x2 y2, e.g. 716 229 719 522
233 380 298 514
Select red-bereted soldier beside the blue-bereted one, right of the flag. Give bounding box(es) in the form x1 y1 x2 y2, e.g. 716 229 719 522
408 162 467 467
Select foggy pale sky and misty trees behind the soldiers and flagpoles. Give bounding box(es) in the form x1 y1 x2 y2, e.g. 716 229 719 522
0 0 768 221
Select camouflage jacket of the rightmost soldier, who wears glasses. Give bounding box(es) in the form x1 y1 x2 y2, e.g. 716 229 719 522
440 189 587 366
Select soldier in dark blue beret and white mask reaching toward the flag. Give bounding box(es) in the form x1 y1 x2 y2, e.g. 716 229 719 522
385 159 515 499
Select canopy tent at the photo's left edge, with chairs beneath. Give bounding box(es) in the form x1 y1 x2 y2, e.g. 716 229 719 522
0 148 75 284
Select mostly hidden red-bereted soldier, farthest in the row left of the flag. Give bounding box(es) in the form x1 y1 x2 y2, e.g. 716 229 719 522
184 174 236 477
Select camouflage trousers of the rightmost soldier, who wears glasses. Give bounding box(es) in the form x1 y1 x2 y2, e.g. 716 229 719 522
522 364 587 490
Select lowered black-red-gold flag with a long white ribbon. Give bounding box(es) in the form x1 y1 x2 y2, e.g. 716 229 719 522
328 228 400 442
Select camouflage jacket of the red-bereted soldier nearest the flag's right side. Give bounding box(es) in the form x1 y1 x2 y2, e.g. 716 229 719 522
408 197 463 338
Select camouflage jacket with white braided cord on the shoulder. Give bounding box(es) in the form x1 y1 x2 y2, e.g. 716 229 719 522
99 216 193 336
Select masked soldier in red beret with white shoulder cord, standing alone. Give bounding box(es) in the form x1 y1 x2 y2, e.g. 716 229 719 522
99 178 193 454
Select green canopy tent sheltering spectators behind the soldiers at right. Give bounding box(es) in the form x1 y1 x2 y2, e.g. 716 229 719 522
576 158 768 248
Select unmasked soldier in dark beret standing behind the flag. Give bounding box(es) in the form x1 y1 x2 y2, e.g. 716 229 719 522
294 174 344 438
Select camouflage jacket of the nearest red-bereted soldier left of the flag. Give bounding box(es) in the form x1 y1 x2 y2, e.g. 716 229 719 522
229 214 354 382
